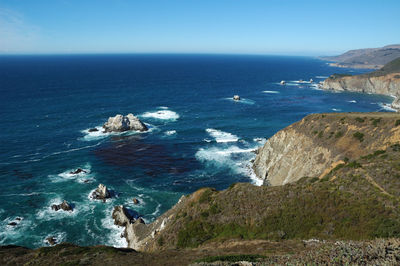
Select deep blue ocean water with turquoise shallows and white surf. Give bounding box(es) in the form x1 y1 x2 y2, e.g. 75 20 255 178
0 55 391 247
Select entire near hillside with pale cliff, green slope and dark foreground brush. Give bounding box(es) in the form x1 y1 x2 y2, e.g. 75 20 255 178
0 113 400 265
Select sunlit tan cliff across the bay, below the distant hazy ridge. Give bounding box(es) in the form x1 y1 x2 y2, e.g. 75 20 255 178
322 72 400 109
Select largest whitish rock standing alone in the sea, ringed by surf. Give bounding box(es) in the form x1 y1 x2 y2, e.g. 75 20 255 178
103 114 148 132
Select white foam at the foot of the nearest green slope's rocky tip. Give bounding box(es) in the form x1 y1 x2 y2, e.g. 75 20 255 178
101 208 128 248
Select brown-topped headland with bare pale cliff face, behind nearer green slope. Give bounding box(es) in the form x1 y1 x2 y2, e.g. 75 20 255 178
253 113 400 186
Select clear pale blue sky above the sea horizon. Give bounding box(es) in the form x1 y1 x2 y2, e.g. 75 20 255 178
0 0 400 55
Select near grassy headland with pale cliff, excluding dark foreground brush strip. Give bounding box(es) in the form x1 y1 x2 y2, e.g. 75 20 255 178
108 113 400 252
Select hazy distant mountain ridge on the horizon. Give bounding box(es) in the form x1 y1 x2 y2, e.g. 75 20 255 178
321 44 400 69
